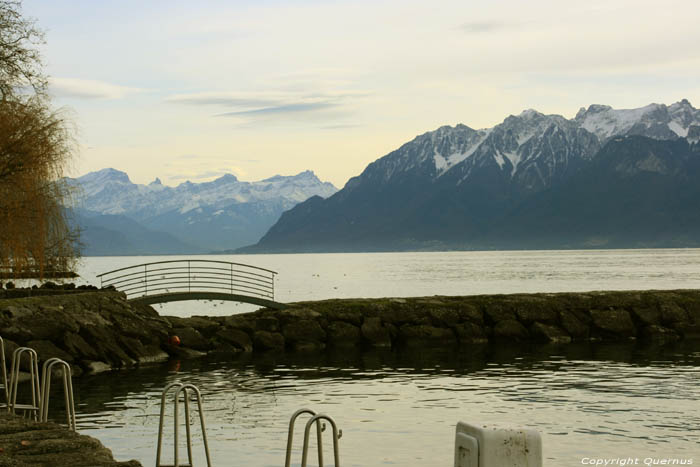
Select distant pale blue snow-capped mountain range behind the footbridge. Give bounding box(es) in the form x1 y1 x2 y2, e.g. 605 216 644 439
67 168 337 256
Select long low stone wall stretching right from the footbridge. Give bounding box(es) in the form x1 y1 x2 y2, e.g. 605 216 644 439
167 291 700 352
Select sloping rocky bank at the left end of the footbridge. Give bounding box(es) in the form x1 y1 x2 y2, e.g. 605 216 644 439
0 291 171 375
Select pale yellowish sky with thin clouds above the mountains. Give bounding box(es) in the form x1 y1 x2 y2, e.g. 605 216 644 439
23 0 700 188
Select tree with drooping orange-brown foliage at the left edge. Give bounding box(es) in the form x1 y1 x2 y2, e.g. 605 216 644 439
0 0 77 277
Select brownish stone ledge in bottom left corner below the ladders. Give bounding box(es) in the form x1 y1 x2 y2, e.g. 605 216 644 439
0 411 141 467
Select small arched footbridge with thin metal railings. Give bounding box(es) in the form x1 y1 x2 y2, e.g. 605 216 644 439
97 259 287 310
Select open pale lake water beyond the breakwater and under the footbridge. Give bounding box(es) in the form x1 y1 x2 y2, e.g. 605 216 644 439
79 249 700 316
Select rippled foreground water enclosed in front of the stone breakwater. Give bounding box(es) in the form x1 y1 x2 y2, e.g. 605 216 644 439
47 342 700 466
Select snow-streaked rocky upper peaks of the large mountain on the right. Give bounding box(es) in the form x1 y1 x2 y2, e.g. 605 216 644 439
360 99 700 194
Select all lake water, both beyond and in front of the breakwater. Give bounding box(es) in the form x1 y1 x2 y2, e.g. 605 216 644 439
56 254 700 466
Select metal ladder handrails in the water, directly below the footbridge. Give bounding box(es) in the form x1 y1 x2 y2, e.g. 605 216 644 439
156 383 211 467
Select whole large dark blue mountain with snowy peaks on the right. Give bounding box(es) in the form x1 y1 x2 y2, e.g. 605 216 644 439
240 99 700 252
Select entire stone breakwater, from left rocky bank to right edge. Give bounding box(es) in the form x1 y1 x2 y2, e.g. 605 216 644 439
0 290 700 374
